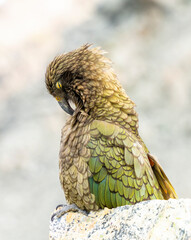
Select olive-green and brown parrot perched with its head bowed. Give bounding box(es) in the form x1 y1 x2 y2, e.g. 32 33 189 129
45 44 177 211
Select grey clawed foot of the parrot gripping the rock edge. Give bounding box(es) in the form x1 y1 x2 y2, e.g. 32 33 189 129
51 204 88 221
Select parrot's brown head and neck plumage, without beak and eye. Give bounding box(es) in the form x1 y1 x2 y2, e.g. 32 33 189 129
46 44 138 135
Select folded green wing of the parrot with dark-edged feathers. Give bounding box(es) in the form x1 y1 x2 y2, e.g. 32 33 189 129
87 120 174 208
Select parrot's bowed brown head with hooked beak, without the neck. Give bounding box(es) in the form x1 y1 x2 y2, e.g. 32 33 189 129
46 44 118 115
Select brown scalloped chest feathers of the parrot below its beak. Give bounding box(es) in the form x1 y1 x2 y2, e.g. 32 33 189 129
59 118 95 209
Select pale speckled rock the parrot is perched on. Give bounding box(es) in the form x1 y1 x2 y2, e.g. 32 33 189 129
49 199 191 240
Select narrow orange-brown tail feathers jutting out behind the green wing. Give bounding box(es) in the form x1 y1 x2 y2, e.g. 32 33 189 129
148 153 178 200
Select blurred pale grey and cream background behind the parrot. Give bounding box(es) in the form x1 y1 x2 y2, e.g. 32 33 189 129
0 0 191 240
